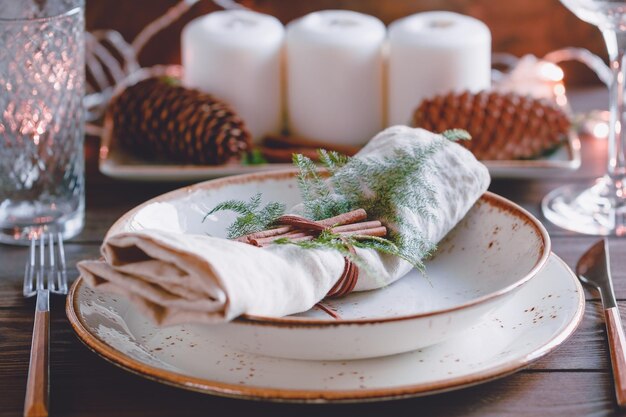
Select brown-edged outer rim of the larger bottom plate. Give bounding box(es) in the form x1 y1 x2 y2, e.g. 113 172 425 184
65 253 585 403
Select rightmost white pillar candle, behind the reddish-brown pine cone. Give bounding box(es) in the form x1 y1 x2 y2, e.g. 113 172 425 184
388 12 491 125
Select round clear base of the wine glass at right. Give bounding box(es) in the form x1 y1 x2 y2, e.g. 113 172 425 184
541 177 626 236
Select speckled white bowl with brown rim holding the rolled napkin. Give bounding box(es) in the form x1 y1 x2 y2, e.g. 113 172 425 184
92 170 550 360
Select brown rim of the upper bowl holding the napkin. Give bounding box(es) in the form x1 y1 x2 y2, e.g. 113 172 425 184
105 168 551 327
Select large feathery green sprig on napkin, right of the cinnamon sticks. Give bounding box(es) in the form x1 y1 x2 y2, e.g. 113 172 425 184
294 142 445 271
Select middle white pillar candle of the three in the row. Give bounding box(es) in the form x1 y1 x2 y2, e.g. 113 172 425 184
287 10 386 145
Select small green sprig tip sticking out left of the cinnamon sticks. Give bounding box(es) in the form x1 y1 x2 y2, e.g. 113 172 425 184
202 193 285 239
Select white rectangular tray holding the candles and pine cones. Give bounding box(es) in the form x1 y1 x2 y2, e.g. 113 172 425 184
99 134 580 182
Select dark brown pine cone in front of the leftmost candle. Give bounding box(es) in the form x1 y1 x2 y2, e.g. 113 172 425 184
109 78 252 165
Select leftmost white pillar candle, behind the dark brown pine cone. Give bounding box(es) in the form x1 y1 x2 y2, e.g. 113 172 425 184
182 10 285 141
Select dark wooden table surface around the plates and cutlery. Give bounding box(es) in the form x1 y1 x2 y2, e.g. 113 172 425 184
0 91 626 416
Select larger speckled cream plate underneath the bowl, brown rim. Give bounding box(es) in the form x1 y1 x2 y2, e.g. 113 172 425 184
67 255 584 402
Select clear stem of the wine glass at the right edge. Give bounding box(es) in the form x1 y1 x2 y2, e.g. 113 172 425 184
602 29 626 184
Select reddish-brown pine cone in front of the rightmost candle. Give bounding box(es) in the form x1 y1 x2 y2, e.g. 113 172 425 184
413 91 570 160
